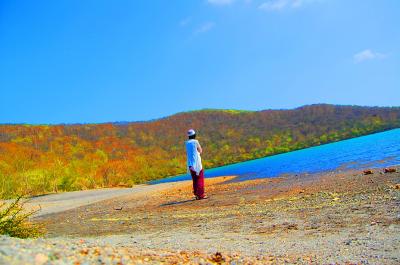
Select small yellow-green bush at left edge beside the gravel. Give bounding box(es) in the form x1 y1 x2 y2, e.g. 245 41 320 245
0 196 44 238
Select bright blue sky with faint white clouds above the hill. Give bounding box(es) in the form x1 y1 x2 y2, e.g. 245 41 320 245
0 0 400 123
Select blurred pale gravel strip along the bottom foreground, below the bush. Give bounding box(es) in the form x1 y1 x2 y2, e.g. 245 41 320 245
0 236 318 265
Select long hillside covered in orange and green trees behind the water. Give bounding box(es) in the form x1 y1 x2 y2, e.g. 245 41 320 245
0 104 400 197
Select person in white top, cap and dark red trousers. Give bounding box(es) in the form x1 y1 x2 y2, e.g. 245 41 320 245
185 129 208 200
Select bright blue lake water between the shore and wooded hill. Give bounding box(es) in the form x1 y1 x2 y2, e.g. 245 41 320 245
153 129 400 183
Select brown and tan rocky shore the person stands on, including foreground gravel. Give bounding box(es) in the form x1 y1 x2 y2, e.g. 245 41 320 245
0 168 400 264
